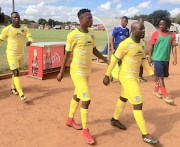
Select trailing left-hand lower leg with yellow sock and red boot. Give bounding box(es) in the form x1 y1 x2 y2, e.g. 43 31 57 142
66 92 82 130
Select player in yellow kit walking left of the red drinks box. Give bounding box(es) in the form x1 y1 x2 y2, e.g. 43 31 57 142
0 12 33 101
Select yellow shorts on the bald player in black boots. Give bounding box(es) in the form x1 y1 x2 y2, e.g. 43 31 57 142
120 78 143 105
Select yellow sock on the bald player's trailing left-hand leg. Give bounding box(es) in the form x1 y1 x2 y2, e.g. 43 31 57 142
113 99 126 120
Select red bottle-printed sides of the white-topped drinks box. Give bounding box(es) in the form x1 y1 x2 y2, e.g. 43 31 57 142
28 45 65 79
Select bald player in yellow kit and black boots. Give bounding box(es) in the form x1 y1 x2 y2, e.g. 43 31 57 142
103 22 159 144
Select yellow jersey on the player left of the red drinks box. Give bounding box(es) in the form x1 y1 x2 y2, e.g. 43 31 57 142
0 25 33 55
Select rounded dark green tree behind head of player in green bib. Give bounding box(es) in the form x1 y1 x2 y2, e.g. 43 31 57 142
148 10 170 27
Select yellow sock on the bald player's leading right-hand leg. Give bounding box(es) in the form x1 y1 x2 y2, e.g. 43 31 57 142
133 110 148 135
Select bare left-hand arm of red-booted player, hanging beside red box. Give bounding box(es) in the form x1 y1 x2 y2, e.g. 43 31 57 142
57 52 71 82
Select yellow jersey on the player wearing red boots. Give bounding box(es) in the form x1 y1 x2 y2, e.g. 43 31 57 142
65 28 96 76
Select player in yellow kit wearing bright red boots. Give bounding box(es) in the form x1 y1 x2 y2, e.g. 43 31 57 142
57 9 109 144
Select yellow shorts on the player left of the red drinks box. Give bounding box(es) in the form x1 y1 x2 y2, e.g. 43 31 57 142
7 55 24 70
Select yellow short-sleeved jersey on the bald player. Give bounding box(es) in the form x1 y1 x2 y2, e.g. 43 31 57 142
114 37 146 78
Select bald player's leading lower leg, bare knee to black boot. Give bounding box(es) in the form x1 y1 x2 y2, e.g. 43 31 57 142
133 103 159 144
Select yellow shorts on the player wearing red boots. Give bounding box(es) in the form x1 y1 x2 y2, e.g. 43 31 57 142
71 74 90 101
